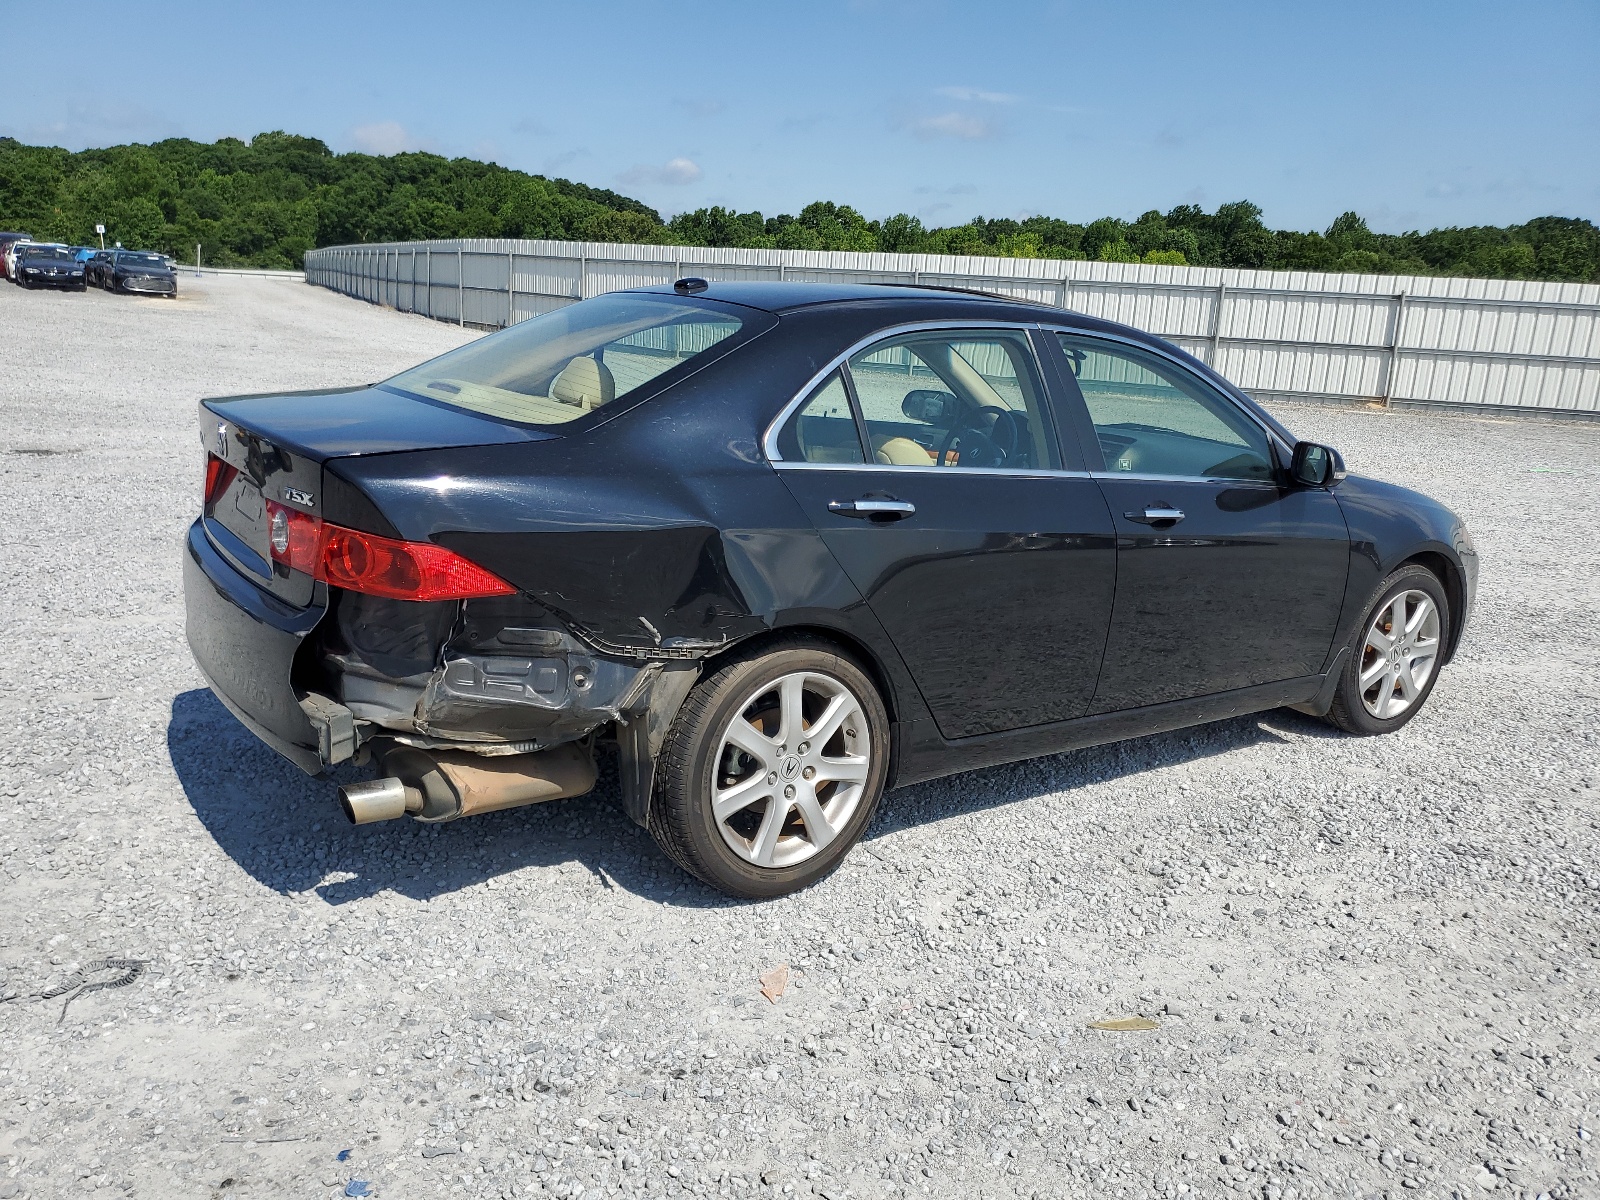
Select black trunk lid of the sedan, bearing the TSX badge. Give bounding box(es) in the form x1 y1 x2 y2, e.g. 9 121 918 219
200 387 552 608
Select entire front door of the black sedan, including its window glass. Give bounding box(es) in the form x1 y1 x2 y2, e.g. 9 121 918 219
1050 333 1349 714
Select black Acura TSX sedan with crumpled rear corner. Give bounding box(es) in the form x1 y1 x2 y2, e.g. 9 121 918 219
184 280 1477 898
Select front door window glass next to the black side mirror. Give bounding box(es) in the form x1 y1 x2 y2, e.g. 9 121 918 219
1058 333 1274 482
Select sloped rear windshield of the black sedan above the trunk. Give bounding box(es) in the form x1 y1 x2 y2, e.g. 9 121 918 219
386 293 744 426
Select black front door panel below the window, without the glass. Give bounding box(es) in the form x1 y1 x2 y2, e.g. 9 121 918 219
1091 475 1350 712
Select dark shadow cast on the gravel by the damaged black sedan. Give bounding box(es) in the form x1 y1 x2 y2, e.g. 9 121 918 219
166 688 1338 907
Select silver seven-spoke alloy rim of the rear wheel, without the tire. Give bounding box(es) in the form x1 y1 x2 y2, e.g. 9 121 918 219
712 670 875 867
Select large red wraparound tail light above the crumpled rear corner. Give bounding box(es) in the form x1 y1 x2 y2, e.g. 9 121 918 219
267 501 517 600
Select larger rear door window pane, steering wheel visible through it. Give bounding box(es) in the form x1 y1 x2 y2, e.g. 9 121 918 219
850 330 1056 470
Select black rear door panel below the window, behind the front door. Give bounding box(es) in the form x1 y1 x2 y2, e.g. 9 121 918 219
779 464 1115 738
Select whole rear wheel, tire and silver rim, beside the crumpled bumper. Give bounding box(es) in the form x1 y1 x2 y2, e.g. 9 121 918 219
650 640 890 899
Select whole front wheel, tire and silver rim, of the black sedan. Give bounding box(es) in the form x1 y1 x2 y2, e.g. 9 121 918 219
1328 563 1450 736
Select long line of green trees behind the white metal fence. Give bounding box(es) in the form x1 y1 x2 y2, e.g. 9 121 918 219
0 131 1600 282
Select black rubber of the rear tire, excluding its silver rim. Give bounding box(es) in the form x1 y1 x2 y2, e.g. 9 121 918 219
658 645 890 899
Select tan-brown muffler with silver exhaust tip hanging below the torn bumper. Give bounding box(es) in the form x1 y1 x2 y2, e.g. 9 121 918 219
339 744 597 826
